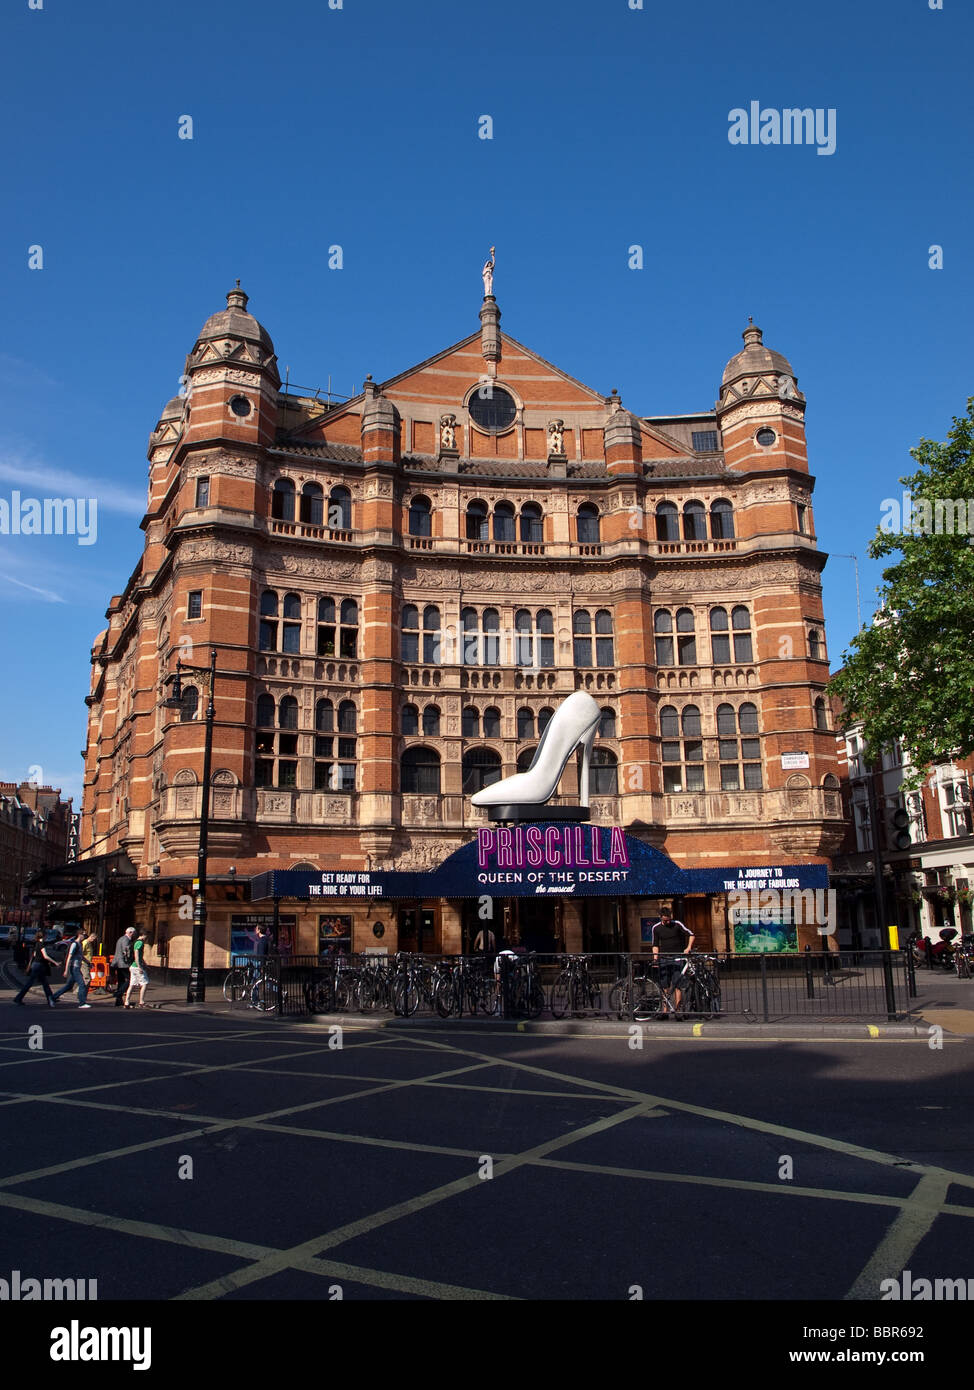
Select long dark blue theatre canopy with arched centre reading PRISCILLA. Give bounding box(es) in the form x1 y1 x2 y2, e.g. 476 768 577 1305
250 823 828 902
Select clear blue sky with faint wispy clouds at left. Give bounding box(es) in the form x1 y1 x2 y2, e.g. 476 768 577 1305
0 0 974 798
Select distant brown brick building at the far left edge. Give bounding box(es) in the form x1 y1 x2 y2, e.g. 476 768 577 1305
0 783 74 923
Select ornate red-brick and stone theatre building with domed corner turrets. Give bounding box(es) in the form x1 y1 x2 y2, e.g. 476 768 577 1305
82 276 843 967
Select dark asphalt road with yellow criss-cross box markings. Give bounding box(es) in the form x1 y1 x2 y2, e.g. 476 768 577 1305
0 994 974 1301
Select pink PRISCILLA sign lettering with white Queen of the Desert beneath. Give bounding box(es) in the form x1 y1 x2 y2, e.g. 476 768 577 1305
477 826 631 892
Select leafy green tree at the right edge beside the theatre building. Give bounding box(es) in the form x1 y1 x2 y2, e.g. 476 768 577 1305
829 396 974 787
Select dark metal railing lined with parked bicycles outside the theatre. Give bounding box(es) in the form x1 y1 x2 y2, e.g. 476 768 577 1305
224 951 916 1023
